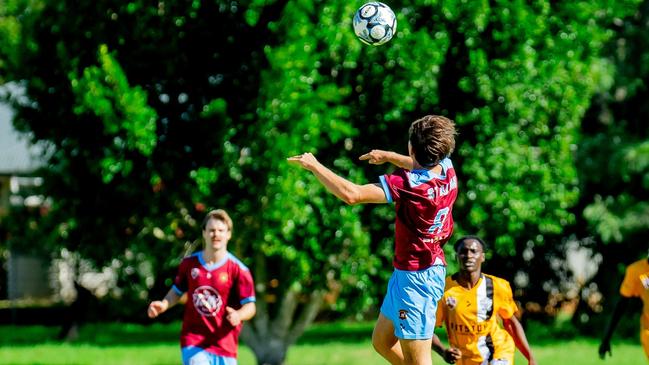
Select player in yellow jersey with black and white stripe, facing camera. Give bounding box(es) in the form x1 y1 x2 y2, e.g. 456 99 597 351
433 236 536 365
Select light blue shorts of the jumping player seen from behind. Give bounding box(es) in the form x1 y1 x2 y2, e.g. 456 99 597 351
381 265 446 340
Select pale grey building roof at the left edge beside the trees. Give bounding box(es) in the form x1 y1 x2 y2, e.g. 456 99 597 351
0 103 41 175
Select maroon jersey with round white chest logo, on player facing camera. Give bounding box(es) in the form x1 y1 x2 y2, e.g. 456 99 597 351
173 252 255 358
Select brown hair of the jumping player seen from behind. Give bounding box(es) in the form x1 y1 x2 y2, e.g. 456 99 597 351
408 115 457 167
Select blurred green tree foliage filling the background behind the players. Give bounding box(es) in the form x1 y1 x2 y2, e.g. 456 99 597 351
0 0 649 342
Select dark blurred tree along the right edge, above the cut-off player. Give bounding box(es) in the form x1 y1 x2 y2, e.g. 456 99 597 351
576 1 649 336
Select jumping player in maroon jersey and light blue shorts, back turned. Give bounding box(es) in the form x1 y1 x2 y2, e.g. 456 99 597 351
288 115 457 365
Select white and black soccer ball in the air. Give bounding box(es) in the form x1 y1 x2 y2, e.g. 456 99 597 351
353 2 397 46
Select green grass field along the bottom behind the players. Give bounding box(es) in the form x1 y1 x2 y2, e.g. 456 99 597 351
0 323 647 365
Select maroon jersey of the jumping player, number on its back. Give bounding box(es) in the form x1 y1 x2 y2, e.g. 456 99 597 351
380 158 457 271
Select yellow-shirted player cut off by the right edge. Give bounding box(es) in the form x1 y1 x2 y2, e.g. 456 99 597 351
599 252 649 361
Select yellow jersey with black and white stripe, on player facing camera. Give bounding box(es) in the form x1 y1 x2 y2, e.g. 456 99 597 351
436 274 517 365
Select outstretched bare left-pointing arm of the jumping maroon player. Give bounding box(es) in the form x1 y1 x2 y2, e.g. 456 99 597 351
287 153 387 205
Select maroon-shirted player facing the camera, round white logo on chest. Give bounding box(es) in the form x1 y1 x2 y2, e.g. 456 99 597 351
148 209 256 365
